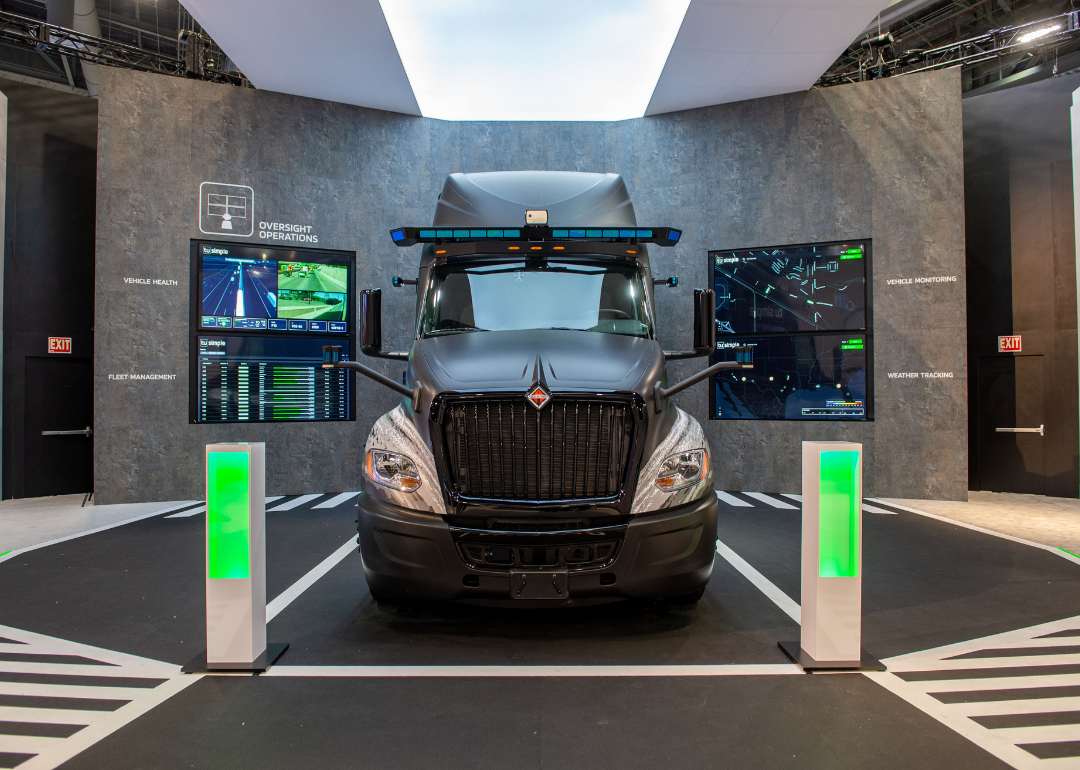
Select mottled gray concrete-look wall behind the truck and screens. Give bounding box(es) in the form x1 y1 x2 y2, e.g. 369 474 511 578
95 68 968 503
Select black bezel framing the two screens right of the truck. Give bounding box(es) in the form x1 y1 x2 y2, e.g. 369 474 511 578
705 238 874 422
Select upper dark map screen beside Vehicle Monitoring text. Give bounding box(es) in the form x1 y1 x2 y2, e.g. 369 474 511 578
708 241 869 335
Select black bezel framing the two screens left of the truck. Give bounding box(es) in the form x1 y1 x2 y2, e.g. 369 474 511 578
188 239 357 425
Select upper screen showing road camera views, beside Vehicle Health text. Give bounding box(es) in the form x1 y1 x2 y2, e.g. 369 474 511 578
199 244 349 334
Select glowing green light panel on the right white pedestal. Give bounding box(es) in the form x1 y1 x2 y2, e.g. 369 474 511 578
818 451 860 578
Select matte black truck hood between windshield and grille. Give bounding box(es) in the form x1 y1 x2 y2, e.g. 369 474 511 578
413 329 662 393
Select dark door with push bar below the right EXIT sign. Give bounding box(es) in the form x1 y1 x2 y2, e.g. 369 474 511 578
978 355 1053 495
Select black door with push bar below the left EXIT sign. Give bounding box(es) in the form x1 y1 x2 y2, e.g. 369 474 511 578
23 356 94 497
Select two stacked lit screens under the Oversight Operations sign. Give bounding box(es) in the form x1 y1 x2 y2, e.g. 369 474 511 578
189 241 356 422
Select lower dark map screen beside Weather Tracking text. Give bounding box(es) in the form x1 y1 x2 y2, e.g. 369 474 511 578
712 334 869 420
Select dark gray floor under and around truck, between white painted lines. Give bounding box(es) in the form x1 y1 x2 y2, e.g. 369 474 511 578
0 494 1080 770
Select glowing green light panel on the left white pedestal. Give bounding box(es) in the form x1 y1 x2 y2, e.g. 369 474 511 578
206 451 252 579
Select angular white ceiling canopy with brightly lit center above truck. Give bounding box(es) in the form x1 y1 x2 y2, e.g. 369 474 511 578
177 0 886 120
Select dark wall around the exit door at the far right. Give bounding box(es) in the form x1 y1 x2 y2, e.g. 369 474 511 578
963 75 1080 497
